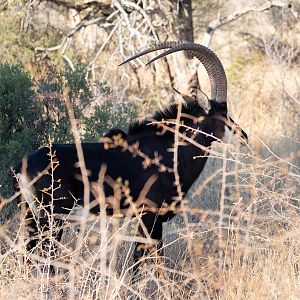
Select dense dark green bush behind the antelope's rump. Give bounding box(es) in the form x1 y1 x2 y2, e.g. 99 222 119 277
0 64 43 196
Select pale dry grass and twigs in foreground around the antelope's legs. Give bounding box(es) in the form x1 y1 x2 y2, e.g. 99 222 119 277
0 136 300 299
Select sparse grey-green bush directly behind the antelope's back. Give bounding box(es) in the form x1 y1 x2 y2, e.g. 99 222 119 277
37 65 137 144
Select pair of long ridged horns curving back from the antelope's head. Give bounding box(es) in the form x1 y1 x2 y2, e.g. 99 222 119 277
122 42 227 102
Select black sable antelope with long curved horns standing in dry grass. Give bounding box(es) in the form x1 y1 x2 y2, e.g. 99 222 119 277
14 42 247 278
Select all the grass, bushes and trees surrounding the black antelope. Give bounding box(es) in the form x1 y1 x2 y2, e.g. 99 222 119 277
0 0 300 299
